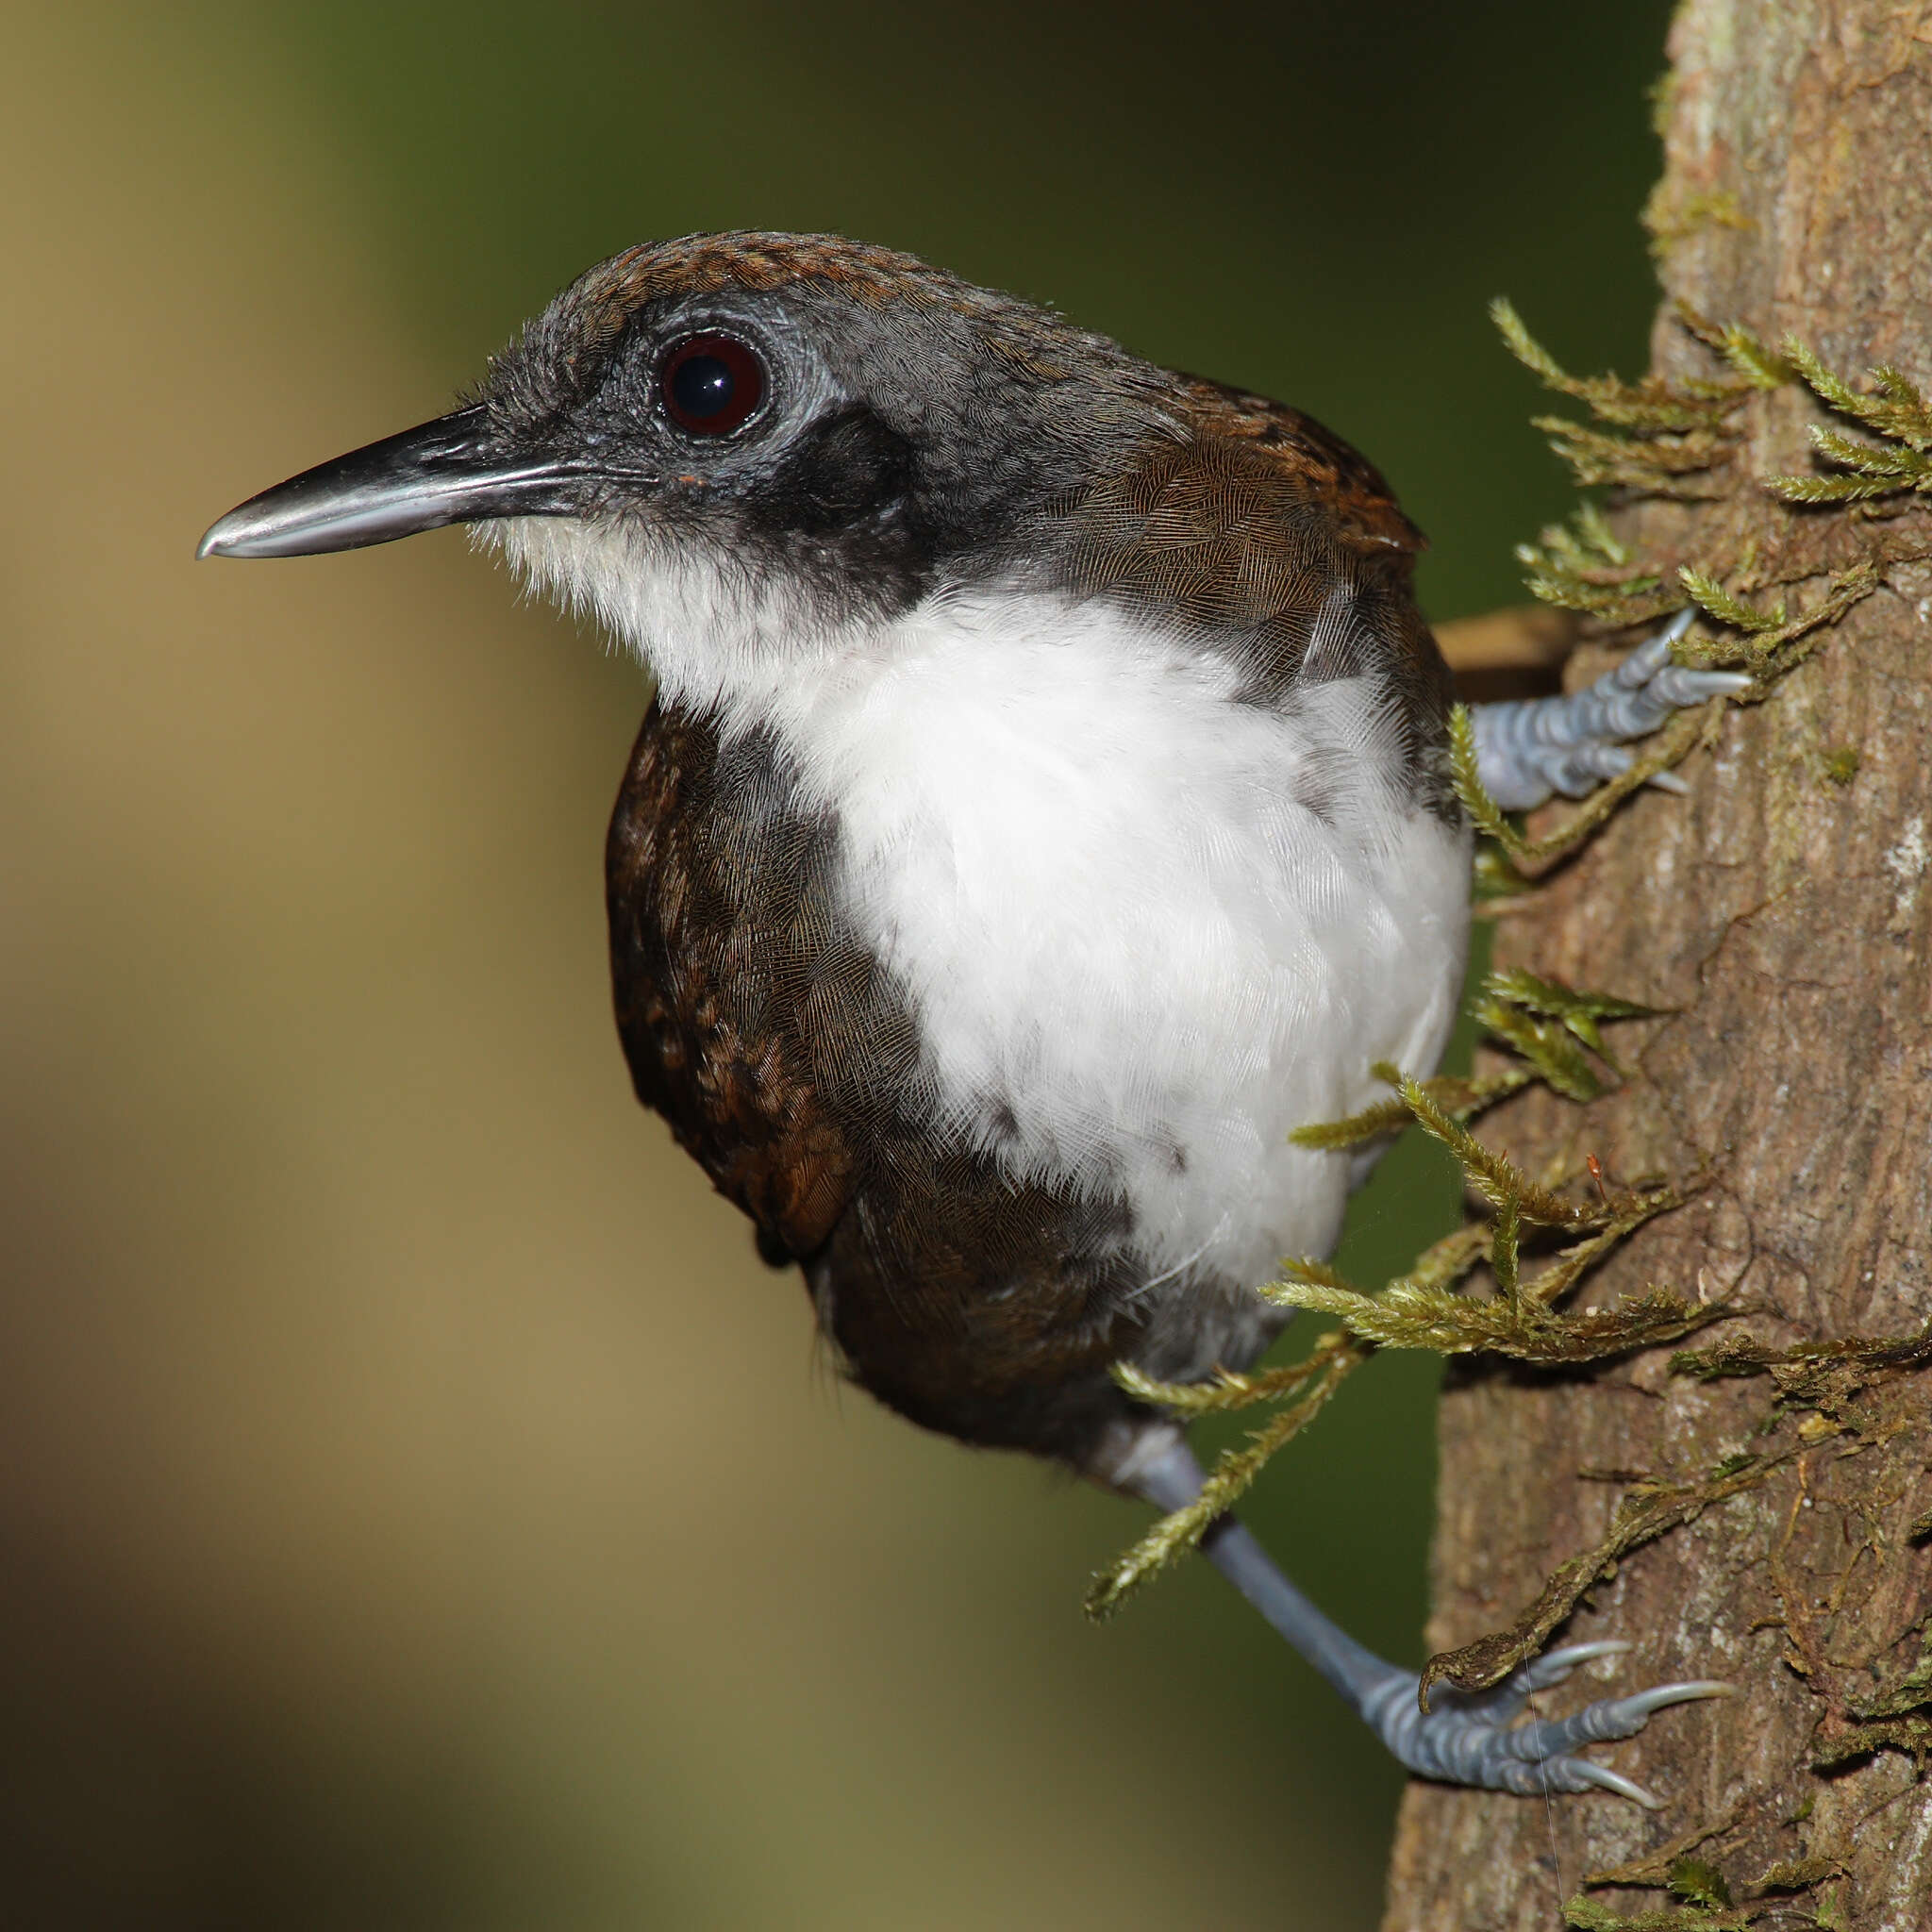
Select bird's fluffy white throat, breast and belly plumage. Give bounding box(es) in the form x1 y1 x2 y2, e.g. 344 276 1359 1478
491 522 1468 1283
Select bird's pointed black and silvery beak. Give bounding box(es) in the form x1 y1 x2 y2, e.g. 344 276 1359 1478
195 406 595 557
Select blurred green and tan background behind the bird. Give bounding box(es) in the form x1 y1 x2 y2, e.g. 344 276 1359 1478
0 0 1667 1928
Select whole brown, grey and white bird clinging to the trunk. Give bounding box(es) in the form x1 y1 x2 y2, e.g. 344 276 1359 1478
201 234 1744 1803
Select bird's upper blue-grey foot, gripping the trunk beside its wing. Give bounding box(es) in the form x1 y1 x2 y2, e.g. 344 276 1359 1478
1468 610 1753 811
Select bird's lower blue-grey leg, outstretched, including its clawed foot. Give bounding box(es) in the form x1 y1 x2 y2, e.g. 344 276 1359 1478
1132 1441 1731 1810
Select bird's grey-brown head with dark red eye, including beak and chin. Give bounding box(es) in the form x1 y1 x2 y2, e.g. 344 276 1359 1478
201 234 1178 695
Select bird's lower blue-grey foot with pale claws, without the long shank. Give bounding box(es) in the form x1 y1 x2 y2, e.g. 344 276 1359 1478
1362 1642 1731 1810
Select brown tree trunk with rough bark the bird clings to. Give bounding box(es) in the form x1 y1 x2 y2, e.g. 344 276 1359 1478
1385 0 1932 1932
